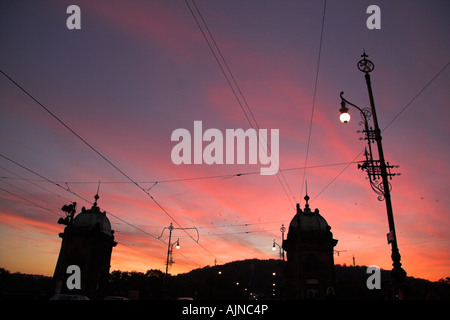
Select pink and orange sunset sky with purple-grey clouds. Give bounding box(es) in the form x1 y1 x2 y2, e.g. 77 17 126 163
0 0 450 281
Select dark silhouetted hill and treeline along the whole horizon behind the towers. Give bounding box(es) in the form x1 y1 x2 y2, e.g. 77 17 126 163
0 259 450 300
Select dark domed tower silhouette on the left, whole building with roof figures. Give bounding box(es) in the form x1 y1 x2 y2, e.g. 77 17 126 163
53 195 117 299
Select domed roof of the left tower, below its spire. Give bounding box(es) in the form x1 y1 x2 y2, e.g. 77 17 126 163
73 203 114 236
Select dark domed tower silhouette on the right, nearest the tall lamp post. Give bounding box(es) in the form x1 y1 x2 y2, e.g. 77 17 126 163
283 195 338 299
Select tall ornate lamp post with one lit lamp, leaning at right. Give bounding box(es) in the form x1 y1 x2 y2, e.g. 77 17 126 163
339 52 406 283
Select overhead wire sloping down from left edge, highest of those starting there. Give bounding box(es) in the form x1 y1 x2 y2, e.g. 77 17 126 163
0 70 216 258
